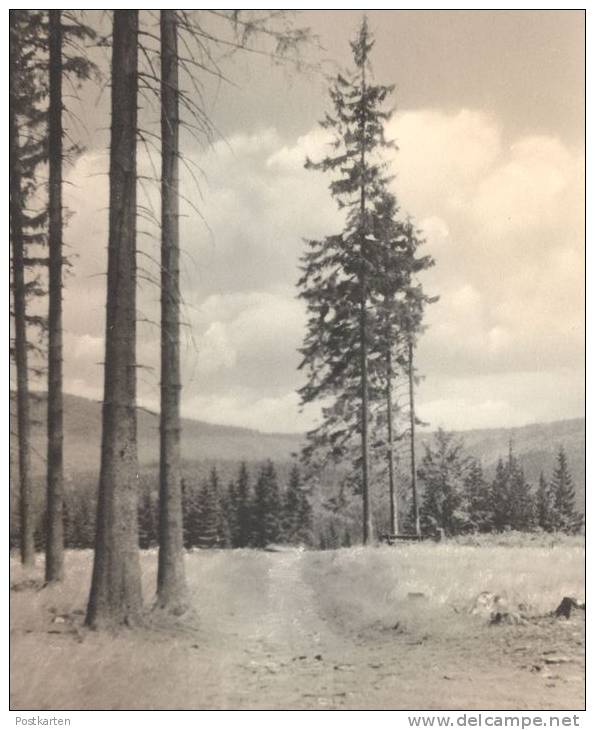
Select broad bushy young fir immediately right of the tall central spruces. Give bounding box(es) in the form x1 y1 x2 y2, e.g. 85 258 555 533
419 428 469 535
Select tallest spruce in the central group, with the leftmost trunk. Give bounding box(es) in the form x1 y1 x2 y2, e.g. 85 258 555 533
298 19 392 544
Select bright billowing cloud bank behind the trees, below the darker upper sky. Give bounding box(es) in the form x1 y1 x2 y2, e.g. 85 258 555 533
65 110 584 430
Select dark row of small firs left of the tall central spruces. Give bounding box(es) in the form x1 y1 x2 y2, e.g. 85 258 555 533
10 460 316 550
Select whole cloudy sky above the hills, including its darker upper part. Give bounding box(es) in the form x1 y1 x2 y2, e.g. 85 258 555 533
58 11 584 431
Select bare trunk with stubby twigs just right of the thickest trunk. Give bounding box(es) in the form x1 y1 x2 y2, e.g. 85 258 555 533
157 10 186 613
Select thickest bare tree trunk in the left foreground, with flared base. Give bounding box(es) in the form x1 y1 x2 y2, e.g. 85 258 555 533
87 10 142 628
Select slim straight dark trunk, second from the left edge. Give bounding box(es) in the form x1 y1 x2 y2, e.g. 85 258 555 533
45 10 64 582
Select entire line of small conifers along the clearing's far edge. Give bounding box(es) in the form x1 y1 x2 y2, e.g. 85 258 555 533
10 431 584 550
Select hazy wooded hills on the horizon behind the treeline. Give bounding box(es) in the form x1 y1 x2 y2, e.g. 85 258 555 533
11 395 585 505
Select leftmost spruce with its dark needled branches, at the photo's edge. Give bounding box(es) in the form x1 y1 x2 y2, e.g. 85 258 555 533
9 10 47 567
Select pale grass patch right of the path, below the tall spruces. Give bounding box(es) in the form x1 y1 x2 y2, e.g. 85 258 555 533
307 537 585 629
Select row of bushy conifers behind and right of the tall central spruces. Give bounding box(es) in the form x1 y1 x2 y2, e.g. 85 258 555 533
316 429 584 548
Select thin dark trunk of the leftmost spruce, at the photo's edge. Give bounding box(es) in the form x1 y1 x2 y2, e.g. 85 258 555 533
9 49 35 567
